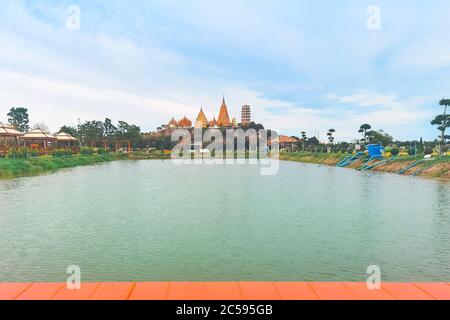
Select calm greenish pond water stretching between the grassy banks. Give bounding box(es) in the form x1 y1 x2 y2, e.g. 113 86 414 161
0 160 450 282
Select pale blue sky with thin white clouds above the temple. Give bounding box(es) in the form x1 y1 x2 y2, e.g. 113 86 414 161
0 0 450 140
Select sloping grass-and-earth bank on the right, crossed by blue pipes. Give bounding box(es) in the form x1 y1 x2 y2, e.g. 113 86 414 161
280 152 450 181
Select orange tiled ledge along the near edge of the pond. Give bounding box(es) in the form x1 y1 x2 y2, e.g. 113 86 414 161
0 282 450 300
